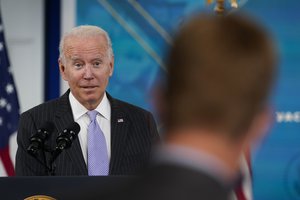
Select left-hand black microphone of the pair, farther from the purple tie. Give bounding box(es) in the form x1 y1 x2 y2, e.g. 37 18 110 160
27 121 54 157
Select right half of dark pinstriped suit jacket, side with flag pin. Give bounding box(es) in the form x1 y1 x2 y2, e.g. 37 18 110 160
107 95 159 175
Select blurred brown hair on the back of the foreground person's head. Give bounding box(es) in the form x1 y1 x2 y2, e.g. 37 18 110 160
166 14 277 137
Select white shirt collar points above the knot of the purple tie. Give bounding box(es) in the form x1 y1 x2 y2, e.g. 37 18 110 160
69 92 111 121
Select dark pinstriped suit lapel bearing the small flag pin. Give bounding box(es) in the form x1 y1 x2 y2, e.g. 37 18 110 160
107 94 130 174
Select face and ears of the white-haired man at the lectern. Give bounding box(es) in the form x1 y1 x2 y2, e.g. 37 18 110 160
59 36 113 109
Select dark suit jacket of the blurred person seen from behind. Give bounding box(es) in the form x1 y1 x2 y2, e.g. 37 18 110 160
107 164 231 200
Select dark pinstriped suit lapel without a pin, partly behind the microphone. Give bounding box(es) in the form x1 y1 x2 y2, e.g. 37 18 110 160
54 90 87 175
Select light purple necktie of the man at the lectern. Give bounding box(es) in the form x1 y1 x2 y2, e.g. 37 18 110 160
87 110 109 176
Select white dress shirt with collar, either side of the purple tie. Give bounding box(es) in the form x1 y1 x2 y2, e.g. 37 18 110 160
69 92 111 163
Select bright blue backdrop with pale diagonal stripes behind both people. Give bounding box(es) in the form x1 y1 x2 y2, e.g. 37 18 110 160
76 0 300 200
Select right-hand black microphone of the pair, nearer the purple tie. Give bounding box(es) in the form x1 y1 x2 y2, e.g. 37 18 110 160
51 122 80 164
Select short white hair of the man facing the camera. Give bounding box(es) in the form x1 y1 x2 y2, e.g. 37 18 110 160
59 25 113 62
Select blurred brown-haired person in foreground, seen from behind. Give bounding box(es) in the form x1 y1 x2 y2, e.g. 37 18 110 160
117 14 276 200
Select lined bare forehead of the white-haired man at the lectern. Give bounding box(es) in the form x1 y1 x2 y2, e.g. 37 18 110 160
64 35 108 57
